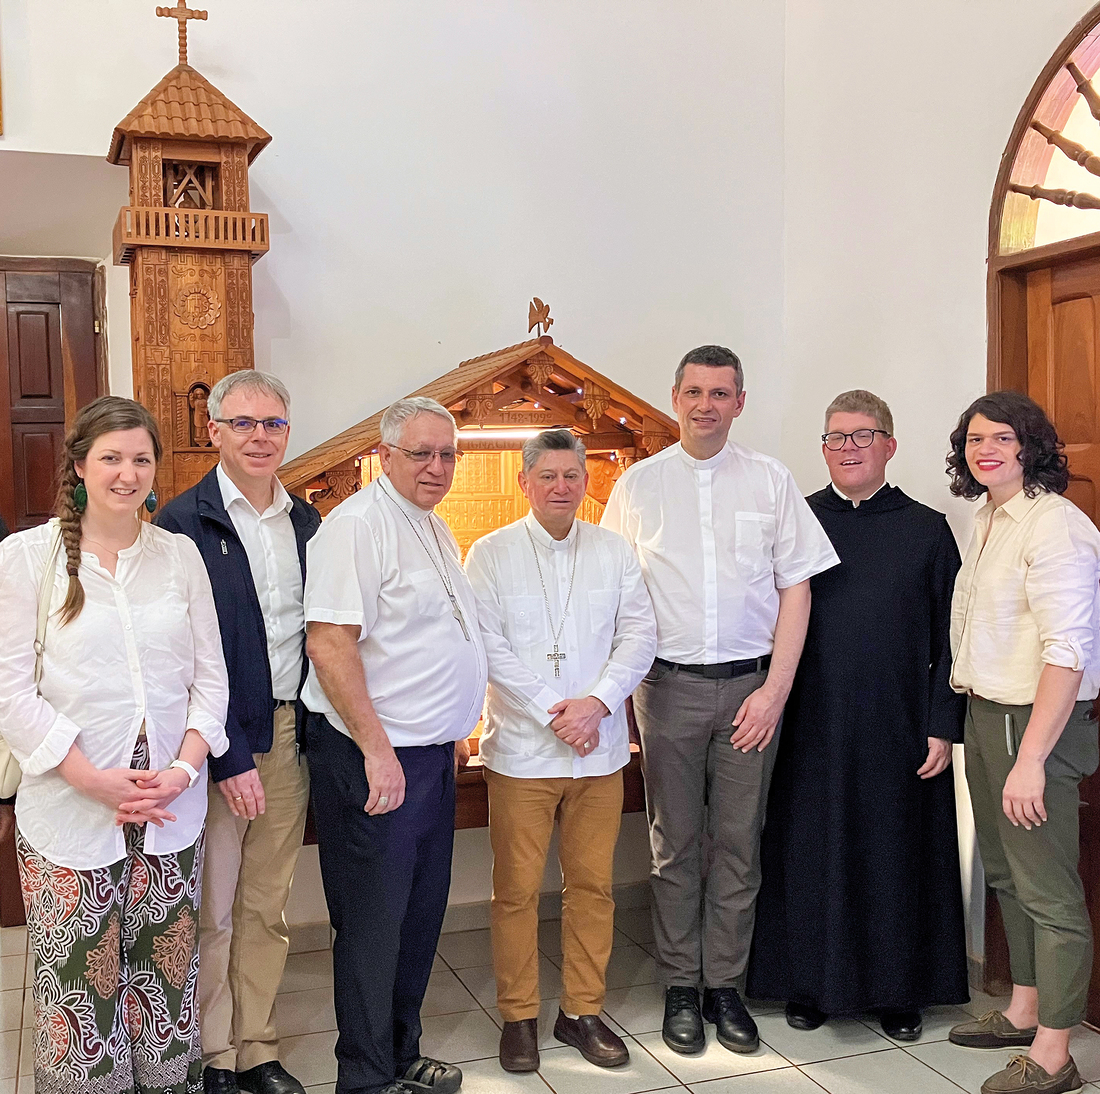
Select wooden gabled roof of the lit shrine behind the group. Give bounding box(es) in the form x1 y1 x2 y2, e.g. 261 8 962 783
279 334 680 493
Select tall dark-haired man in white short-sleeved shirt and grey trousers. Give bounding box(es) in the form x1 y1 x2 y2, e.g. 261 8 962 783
602 345 839 1053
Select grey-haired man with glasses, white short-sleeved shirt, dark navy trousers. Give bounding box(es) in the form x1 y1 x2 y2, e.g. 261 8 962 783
303 397 486 1094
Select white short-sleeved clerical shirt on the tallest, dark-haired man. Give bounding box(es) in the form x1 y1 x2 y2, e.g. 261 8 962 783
601 443 840 665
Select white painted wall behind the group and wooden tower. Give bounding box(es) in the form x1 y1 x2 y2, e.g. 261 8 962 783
0 0 1088 946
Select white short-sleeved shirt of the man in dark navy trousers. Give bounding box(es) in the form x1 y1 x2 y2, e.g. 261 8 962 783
301 475 486 748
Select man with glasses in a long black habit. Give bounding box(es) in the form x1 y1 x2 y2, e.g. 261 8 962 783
747 390 969 1041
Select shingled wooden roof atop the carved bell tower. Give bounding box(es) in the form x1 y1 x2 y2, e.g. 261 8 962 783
107 65 271 164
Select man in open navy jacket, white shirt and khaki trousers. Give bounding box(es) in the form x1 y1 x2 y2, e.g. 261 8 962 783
156 369 321 1094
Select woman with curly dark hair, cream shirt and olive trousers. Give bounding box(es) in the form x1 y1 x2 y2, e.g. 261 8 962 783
947 391 1100 1094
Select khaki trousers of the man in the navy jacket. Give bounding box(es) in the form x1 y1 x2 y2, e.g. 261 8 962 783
199 704 309 1071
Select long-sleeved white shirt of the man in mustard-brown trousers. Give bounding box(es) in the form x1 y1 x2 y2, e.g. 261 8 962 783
466 513 657 778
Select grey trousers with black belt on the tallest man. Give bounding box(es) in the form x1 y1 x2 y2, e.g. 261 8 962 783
634 663 779 987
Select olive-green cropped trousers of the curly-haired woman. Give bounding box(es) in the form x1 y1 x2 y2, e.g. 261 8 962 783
966 698 1100 1029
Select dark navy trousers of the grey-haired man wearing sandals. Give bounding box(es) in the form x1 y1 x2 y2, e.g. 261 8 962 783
306 715 454 1094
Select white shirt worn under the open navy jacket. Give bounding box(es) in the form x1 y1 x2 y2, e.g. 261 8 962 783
217 464 306 701
